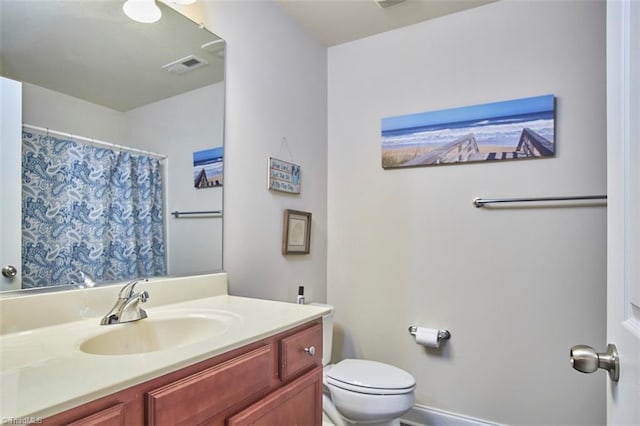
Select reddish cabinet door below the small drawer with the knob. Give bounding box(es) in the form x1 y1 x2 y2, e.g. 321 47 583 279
227 367 322 426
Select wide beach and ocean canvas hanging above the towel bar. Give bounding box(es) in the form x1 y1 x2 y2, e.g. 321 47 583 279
381 95 555 169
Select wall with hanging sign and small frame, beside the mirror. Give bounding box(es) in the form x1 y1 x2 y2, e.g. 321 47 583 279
185 1 327 301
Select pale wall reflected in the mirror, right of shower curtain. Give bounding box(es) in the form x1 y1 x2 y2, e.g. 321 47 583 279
124 83 224 275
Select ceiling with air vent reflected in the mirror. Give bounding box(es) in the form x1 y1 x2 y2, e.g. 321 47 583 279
0 0 224 111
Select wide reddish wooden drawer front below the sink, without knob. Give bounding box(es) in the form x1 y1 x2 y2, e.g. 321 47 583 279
146 345 274 425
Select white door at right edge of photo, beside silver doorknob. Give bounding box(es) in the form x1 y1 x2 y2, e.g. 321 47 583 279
607 0 640 425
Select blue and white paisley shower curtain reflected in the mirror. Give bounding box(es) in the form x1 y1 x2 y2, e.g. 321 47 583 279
22 127 166 288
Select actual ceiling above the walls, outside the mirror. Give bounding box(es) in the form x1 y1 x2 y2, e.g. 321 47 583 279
275 0 496 46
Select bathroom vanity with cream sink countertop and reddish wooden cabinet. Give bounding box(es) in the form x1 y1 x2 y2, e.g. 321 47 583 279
0 274 325 425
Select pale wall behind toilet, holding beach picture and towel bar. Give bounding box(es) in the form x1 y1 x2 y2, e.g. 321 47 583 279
327 1 606 425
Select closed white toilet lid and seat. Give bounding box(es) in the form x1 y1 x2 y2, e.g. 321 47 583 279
326 359 416 394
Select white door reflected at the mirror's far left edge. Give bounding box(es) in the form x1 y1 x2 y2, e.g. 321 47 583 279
0 77 22 290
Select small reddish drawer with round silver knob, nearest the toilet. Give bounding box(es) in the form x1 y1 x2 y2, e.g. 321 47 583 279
278 324 322 382
